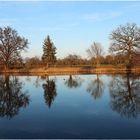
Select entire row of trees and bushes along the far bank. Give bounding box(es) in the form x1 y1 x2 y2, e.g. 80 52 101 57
0 23 140 70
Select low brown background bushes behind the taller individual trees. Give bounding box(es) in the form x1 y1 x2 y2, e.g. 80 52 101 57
10 54 140 69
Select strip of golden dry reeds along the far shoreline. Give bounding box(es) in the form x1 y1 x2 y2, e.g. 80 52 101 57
0 67 140 75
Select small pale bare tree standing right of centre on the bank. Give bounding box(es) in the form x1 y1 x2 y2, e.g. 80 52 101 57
87 42 103 66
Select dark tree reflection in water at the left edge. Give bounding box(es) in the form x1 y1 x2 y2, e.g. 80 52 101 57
0 75 29 118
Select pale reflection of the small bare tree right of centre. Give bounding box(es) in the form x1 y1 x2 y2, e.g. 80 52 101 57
87 74 104 99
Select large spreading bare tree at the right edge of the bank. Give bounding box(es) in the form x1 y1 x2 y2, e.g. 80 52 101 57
109 23 140 68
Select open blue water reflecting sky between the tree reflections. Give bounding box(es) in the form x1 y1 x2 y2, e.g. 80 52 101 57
0 75 140 138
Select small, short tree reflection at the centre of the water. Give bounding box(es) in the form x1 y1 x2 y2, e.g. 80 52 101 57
65 75 82 88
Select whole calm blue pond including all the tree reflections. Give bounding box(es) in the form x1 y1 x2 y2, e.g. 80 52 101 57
0 75 140 139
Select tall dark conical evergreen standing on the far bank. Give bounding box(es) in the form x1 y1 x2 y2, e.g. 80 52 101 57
42 36 56 66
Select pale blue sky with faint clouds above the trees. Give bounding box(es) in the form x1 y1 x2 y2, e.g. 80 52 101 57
0 1 140 58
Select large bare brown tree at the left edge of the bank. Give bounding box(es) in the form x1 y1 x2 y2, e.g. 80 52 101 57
0 27 28 70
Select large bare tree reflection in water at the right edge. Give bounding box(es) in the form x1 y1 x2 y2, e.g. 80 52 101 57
110 74 140 118
